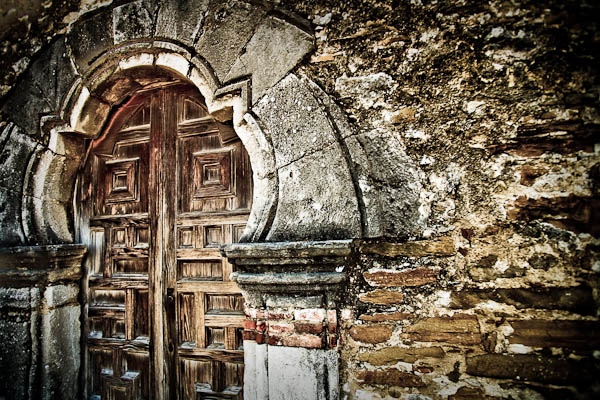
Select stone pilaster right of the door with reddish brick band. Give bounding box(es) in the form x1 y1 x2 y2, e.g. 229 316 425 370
222 240 353 400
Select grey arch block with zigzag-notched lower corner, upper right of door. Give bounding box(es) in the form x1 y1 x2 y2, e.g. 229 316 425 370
225 16 313 104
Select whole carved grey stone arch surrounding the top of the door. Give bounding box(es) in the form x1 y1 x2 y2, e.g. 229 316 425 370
0 0 381 248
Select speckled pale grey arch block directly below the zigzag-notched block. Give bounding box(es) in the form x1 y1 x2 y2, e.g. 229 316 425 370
253 75 342 168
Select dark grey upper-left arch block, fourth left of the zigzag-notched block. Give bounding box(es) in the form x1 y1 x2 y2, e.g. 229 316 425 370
67 10 113 73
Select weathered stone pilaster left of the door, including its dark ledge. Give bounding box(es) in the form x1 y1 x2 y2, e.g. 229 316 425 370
0 245 86 399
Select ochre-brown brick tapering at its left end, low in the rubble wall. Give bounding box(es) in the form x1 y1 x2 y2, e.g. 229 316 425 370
401 314 482 345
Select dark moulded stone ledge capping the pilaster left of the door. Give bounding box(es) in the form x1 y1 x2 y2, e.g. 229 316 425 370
0 244 86 286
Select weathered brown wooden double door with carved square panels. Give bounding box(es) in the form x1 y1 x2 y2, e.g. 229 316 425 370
79 84 252 399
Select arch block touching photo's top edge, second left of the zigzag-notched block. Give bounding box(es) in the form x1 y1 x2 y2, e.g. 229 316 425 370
155 0 208 47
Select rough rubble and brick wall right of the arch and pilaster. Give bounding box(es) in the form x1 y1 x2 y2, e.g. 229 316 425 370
274 1 600 399
